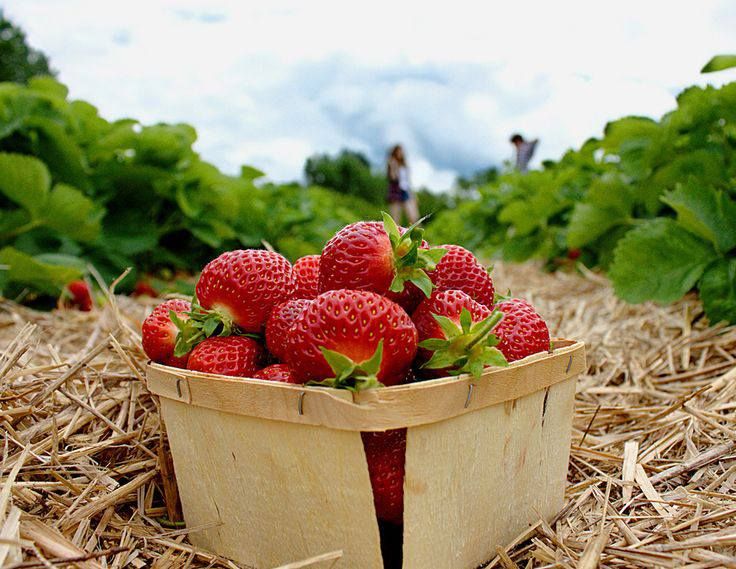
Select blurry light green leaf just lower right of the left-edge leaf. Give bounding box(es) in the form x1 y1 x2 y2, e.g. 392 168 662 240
44 184 104 242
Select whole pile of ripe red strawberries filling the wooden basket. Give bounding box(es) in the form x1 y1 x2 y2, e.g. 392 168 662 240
143 214 550 523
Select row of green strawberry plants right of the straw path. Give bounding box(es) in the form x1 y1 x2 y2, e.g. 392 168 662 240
428 77 736 322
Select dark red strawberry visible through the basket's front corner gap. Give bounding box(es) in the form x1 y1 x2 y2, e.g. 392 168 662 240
360 429 406 524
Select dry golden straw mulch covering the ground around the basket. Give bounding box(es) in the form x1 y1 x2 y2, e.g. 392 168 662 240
0 265 736 569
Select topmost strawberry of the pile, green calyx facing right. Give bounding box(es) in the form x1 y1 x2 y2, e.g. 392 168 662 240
319 213 445 302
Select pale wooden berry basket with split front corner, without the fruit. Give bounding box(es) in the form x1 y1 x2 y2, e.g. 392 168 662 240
147 340 585 569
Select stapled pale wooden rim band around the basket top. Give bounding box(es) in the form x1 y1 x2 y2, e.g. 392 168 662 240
147 340 586 431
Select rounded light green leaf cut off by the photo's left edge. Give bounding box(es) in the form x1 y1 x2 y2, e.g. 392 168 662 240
0 153 51 219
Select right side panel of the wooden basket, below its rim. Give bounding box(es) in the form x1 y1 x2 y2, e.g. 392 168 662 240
404 378 575 569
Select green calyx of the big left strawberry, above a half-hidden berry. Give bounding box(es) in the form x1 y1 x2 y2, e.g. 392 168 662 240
169 298 258 357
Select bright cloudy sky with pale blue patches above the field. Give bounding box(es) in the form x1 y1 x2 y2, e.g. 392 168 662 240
2 0 736 191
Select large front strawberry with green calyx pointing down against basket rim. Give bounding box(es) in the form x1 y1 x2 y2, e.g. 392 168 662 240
285 290 417 389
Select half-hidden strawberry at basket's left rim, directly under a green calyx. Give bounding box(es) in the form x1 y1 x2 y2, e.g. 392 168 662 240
187 336 263 377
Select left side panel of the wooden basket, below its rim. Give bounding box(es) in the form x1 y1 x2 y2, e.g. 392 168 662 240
161 398 383 569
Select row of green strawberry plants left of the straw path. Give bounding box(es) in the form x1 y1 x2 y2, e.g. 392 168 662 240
0 77 380 295
